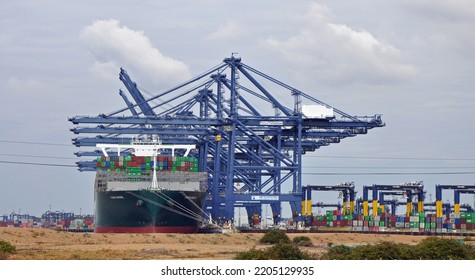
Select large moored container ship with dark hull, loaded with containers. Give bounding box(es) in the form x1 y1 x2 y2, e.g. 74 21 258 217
94 138 207 233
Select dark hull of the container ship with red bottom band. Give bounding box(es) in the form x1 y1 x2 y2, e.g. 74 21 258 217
94 189 205 233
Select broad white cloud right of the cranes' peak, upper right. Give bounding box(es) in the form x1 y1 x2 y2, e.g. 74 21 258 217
264 4 417 84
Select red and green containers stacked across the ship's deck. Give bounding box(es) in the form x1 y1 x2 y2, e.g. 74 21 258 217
96 155 198 176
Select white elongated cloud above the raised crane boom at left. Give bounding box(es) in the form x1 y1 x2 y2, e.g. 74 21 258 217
80 19 191 85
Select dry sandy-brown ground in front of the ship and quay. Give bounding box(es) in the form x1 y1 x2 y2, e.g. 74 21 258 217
0 228 470 260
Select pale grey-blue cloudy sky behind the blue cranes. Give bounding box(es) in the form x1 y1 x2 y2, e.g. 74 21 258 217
0 0 475 215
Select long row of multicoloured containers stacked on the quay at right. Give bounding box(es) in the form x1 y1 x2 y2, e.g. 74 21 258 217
312 210 475 233
